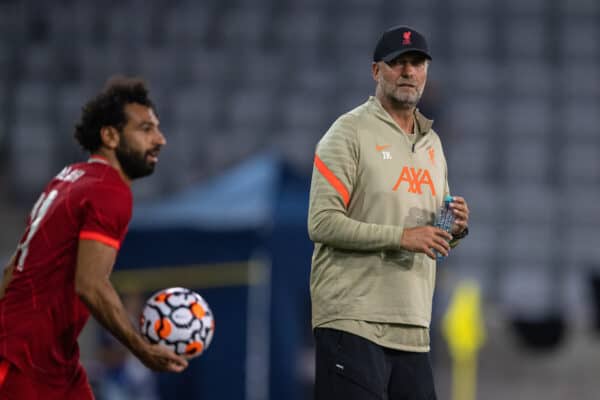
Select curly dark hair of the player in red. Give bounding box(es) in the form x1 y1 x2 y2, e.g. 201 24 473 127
75 76 156 153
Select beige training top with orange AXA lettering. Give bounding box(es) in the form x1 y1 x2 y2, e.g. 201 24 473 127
308 97 449 351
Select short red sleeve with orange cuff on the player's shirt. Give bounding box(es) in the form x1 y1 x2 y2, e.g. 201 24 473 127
79 182 132 250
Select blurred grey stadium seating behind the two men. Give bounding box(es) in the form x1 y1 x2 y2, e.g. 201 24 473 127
0 0 600 344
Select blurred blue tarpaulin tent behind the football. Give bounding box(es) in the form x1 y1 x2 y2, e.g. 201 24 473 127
117 154 312 400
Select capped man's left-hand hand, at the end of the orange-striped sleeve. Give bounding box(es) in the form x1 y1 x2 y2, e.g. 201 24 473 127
400 226 452 260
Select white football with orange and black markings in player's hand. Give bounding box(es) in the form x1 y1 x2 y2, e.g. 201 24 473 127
140 287 215 359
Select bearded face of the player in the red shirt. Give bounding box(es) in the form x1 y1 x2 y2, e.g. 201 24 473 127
116 103 167 179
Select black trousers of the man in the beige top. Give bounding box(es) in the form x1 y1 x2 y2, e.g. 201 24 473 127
314 328 437 400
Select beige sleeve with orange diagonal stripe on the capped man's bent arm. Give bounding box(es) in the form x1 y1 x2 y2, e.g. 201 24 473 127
308 114 403 251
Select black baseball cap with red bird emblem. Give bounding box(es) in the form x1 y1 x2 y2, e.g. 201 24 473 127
373 25 431 62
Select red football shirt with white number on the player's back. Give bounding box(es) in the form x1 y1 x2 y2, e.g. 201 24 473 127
0 157 132 385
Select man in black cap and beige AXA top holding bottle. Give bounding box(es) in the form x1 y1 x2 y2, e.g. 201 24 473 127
308 26 469 400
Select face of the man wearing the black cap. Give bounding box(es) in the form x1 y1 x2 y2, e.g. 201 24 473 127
374 53 429 108
